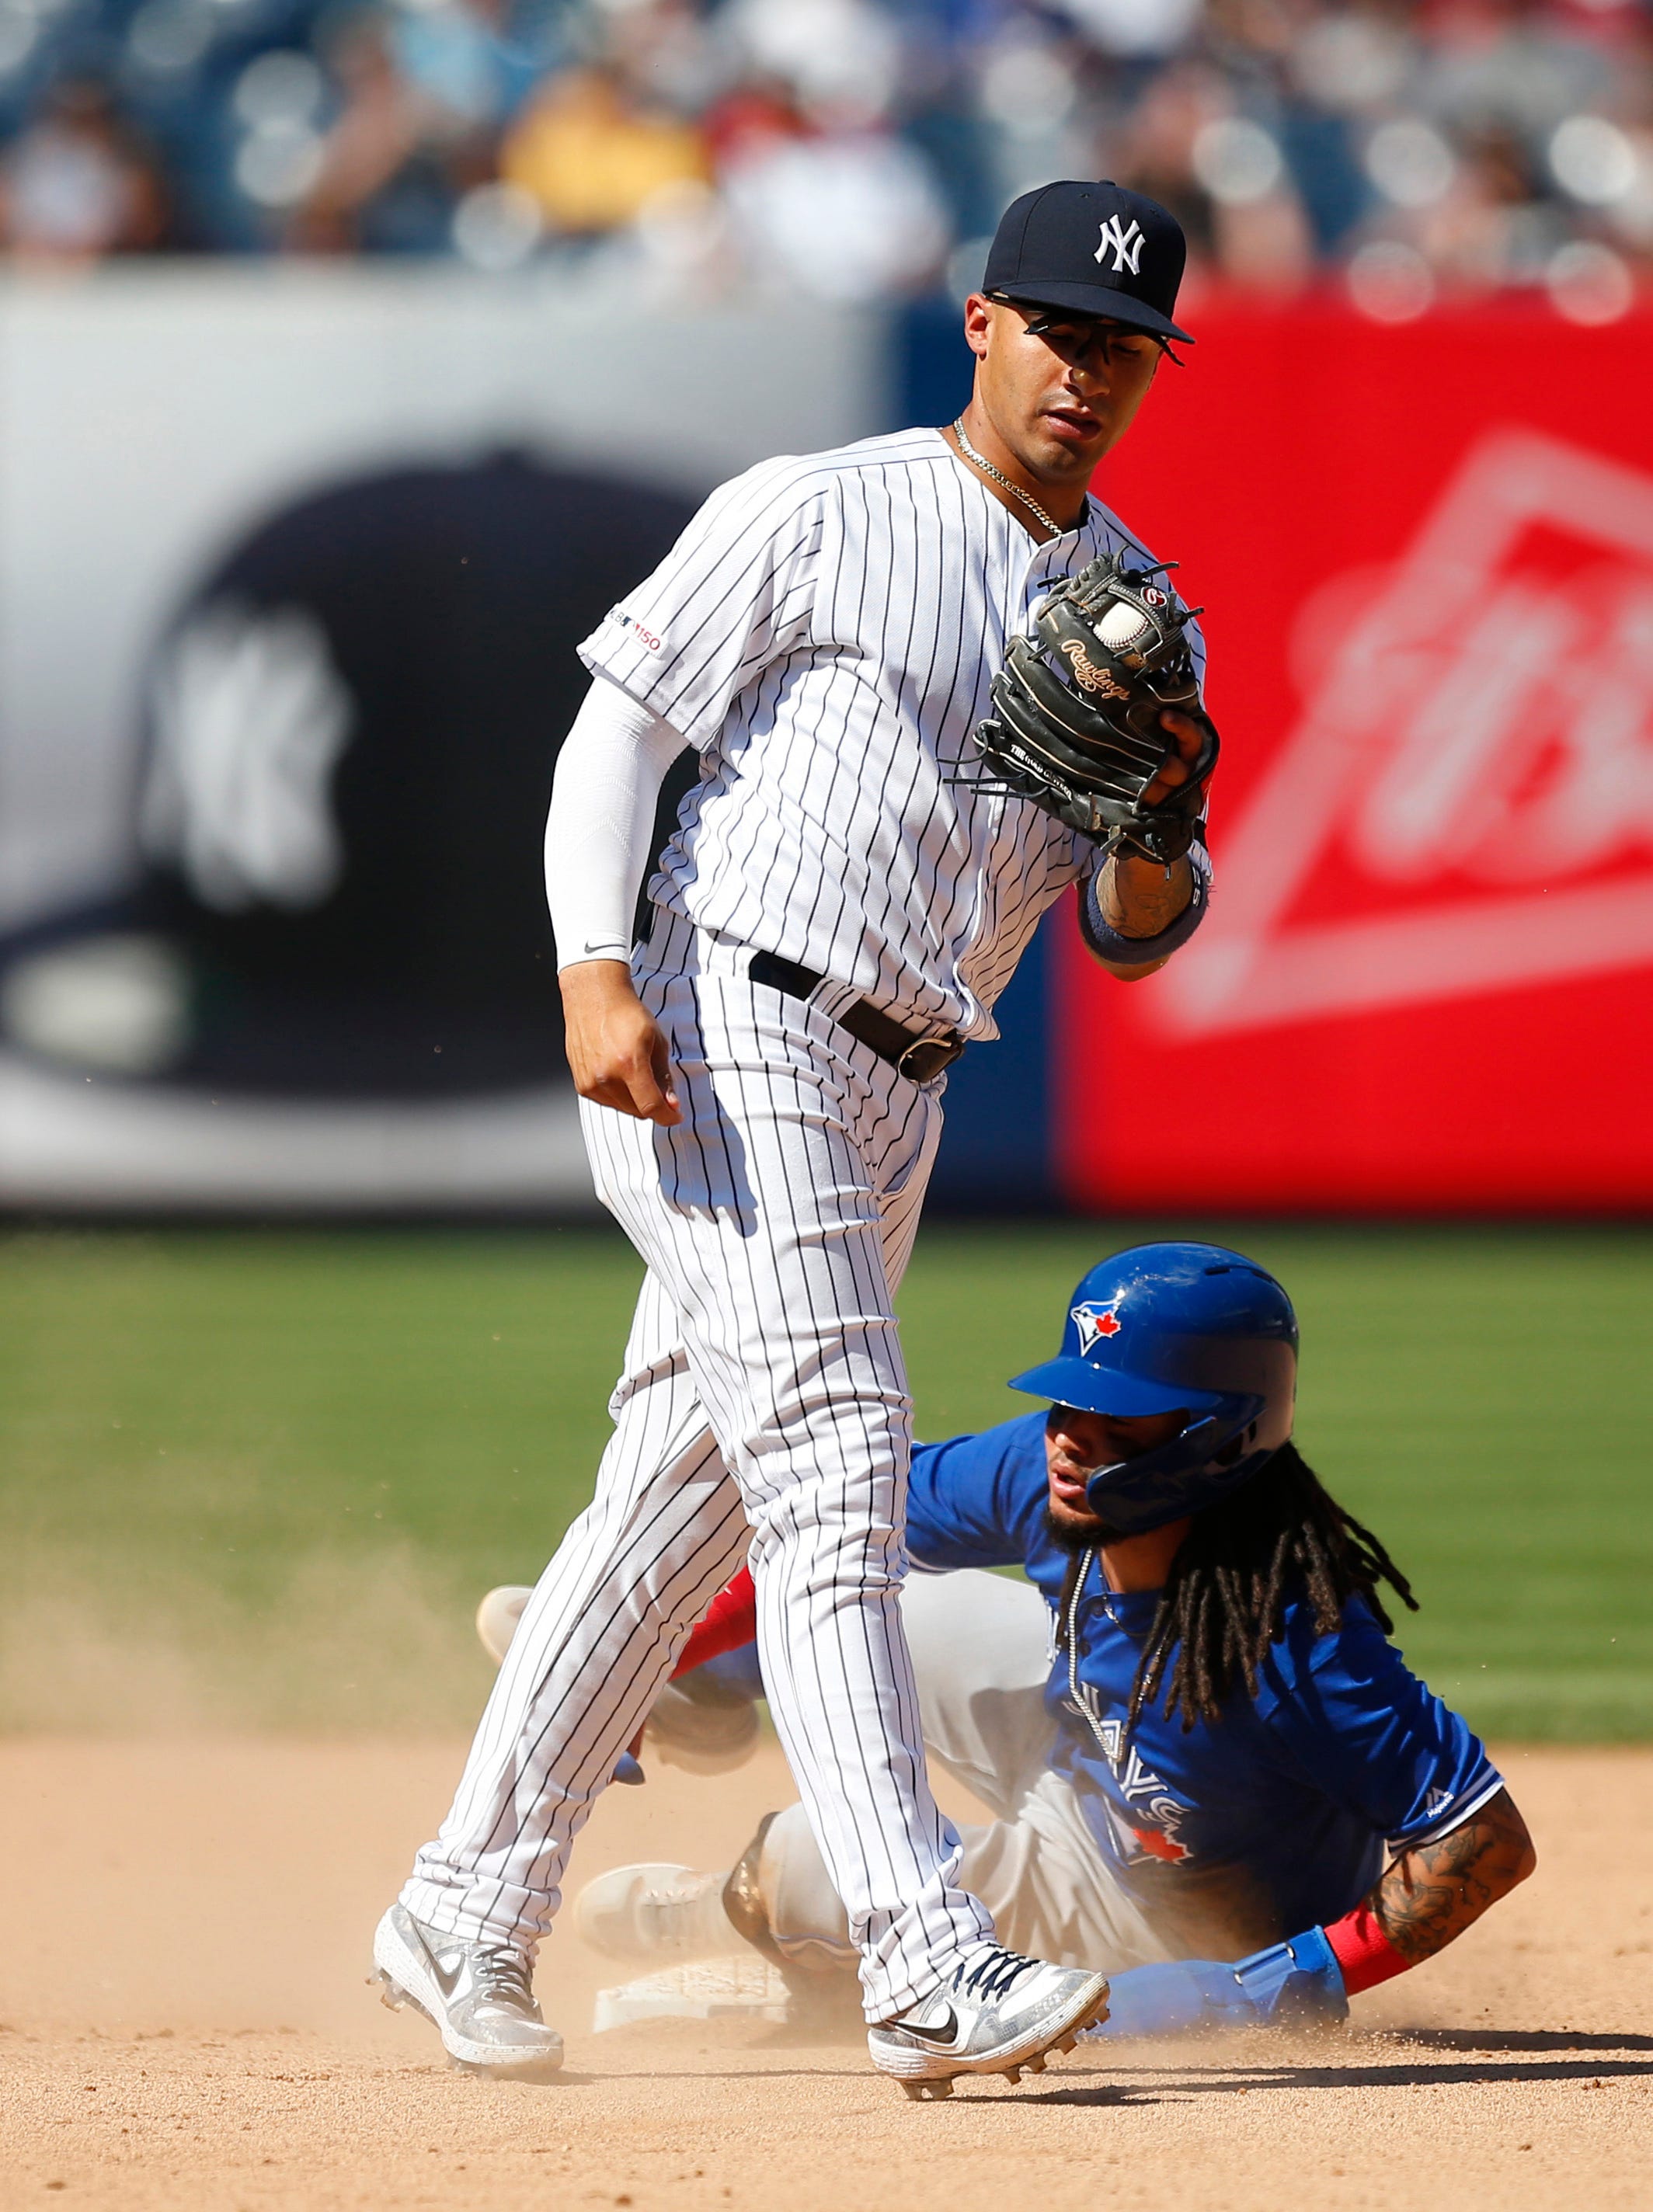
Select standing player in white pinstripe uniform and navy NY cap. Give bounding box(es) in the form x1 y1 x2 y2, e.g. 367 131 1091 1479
374 183 1215 2095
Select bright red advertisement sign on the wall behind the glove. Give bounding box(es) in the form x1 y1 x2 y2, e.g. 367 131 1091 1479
1053 305 1653 1212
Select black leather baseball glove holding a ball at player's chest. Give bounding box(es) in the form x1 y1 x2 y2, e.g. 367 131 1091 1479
976 553 1217 863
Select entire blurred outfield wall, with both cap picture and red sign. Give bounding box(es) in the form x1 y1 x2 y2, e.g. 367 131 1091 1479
0 270 1653 1212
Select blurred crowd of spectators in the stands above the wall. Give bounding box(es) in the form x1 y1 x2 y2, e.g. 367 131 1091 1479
0 0 1653 321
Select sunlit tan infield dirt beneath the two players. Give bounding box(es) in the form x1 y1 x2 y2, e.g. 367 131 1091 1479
0 1741 1653 2212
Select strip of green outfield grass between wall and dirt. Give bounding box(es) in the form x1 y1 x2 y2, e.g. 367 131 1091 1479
0 1226 1653 1741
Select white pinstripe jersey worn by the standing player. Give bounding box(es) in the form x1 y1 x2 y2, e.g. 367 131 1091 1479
579 430 1204 1038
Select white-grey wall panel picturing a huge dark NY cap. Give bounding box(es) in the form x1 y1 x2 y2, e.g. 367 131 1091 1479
0 266 889 1212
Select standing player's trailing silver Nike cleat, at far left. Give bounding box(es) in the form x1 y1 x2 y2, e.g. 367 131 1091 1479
374 1904 562 2082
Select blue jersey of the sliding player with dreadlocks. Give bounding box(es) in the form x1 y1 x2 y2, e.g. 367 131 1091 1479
907 1414 1502 1949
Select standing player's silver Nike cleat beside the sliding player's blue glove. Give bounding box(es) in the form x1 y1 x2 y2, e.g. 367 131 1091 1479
868 1942 1108 2097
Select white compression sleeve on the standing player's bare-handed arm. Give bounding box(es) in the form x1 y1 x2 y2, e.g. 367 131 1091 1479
545 676 686 969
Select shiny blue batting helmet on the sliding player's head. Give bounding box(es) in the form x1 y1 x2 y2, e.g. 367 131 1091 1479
1011 1243 1296 1536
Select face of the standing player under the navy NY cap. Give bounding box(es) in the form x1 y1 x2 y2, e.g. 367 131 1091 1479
965 292 1160 485
